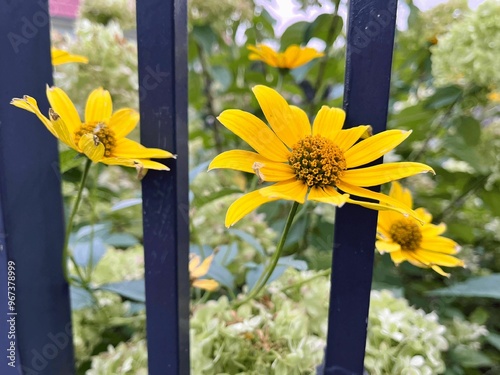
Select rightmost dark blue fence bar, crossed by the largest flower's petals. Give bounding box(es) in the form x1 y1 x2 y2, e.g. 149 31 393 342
324 0 397 375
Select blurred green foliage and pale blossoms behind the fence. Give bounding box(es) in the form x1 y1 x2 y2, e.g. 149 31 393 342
53 0 500 375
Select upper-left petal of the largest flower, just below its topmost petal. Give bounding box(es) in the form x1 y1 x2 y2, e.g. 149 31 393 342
217 109 290 162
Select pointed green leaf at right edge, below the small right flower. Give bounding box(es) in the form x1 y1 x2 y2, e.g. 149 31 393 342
428 273 500 299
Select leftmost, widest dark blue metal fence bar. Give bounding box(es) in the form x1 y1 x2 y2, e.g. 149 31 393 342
0 0 74 375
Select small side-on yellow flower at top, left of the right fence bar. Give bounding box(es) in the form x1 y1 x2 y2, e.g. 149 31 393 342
247 44 324 69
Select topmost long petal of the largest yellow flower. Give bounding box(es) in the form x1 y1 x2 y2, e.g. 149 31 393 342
252 85 311 148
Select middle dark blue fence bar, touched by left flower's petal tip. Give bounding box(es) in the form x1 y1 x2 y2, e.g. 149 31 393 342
137 0 189 375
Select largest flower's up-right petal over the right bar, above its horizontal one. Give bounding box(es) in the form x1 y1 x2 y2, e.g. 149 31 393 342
344 130 411 168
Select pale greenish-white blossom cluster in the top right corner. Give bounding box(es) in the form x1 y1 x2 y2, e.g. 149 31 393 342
431 0 500 89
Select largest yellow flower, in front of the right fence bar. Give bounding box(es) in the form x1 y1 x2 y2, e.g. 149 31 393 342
209 86 433 226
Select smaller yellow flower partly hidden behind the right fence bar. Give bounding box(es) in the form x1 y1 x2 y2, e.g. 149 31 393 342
375 182 465 277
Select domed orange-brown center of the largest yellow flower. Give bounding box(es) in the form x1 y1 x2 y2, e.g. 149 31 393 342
288 135 347 187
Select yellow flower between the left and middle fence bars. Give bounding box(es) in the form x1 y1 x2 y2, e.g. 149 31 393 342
11 86 175 171
